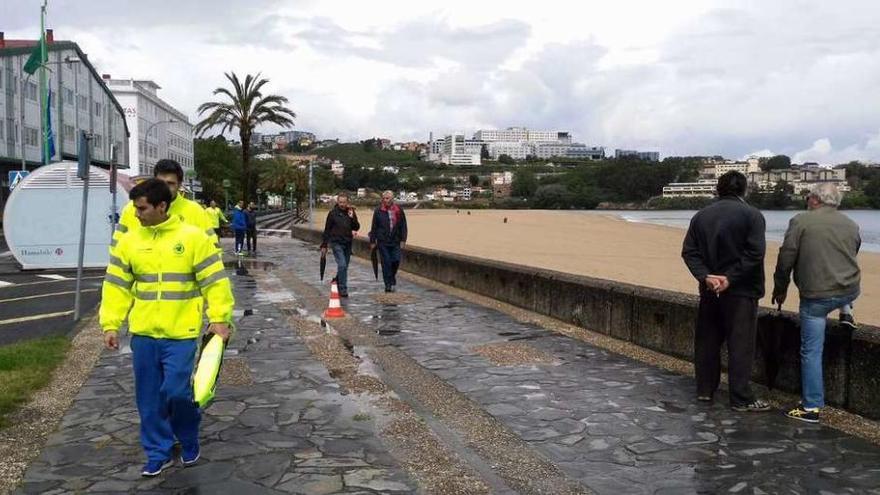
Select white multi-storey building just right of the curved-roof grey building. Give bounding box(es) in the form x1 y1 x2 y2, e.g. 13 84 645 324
105 76 195 176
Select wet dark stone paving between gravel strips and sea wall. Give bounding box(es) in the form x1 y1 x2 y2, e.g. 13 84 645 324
270 241 880 494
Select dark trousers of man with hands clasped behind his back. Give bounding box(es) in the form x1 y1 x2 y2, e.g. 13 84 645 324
694 293 758 407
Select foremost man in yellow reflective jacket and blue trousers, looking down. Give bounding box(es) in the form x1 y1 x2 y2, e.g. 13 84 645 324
100 179 235 476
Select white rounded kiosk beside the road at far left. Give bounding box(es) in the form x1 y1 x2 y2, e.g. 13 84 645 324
3 161 133 270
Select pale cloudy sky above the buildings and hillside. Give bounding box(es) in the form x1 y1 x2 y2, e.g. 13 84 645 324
0 0 880 163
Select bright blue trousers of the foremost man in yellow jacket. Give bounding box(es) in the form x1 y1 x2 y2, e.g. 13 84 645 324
131 335 201 461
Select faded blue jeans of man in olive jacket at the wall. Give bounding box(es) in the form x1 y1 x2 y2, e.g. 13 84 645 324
800 292 859 408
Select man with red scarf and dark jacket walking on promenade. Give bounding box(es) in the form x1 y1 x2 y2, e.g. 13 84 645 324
370 191 407 292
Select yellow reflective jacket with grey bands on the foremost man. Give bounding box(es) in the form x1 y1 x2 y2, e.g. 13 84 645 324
100 216 235 339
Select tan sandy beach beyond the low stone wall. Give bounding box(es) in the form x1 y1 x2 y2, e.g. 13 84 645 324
398 210 880 326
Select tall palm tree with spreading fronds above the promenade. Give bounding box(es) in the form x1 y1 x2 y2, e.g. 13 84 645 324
193 72 296 203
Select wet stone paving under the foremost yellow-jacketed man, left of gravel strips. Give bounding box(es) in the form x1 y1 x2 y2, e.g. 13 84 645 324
19 254 415 494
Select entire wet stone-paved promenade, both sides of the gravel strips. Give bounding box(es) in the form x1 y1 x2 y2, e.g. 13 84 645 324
12 239 880 494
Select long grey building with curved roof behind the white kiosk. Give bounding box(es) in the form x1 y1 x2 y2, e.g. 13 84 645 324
0 35 129 174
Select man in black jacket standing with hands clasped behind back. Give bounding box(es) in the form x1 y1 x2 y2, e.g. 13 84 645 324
681 171 770 412
